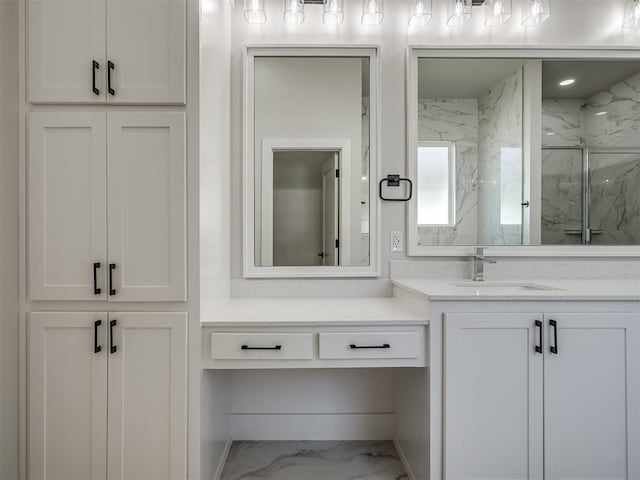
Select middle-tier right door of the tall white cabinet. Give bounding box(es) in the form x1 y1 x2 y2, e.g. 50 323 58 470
107 112 186 301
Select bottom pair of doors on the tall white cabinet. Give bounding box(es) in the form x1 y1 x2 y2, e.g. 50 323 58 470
28 312 187 480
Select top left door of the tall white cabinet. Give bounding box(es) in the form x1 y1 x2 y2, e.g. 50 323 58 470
27 0 105 103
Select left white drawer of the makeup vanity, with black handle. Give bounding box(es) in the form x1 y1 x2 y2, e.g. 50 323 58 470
211 332 313 360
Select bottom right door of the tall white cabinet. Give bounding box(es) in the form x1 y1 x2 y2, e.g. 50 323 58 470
108 313 187 480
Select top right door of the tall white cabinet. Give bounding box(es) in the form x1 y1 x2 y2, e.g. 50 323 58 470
107 0 186 104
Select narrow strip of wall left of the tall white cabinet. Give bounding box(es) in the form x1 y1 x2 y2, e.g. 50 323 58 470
0 0 19 480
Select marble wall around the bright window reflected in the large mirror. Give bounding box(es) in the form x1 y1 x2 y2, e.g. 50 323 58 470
418 98 478 245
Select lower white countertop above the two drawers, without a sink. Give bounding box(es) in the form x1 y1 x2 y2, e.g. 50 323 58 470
201 297 429 327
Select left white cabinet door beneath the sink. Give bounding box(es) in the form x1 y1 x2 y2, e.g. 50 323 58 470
444 314 543 480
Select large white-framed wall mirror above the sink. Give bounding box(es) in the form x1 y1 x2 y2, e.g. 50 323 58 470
407 48 640 256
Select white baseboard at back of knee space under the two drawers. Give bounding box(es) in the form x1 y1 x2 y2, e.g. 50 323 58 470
230 413 396 440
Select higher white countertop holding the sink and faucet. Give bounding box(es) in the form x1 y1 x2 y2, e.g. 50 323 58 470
391 279 640 301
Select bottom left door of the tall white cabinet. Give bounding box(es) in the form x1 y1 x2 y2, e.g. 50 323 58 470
28 313 107 480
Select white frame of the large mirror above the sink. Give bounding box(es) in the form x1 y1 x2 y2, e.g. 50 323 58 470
406 45 640 257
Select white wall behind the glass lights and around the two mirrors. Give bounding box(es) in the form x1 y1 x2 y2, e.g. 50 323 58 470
231 0 640 284
